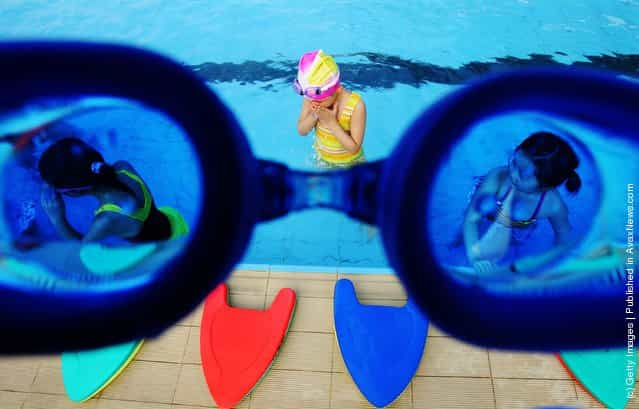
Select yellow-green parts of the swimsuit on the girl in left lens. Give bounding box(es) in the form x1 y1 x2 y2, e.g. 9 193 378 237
94 169 189 239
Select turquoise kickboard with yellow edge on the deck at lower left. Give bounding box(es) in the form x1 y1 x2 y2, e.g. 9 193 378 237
62 341 142 402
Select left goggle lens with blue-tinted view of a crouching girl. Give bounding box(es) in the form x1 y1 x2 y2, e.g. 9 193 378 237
0 97 202 291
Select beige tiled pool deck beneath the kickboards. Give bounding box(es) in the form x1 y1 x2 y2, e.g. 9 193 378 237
0 270 628 409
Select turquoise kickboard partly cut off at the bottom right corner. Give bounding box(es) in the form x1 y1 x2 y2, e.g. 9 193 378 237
561 348 637 409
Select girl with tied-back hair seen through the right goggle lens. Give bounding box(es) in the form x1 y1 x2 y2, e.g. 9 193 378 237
463 132 581 274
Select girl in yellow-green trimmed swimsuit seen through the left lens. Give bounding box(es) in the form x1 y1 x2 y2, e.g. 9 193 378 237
38 138 188 243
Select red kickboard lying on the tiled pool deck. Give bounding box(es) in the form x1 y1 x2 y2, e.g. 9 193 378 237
200 284 295 408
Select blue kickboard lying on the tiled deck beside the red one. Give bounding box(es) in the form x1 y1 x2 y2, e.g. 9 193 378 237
333 279 428 408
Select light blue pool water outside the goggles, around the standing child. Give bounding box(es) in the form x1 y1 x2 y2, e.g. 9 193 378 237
0 0 639 272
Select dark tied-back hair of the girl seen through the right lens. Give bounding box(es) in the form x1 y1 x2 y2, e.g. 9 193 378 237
517 132 581 193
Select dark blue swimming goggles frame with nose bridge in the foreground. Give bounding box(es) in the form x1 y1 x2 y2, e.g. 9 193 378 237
0 42 639 353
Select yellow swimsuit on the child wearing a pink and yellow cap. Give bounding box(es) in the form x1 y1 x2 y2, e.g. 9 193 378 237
314 92 364 166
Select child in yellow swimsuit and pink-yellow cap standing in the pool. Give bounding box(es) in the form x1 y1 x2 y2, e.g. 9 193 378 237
294 50 366 168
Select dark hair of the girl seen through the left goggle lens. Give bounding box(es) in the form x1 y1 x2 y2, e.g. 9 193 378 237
38 138 117 189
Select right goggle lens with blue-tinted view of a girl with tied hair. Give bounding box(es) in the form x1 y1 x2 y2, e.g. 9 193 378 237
427 112 639 290
